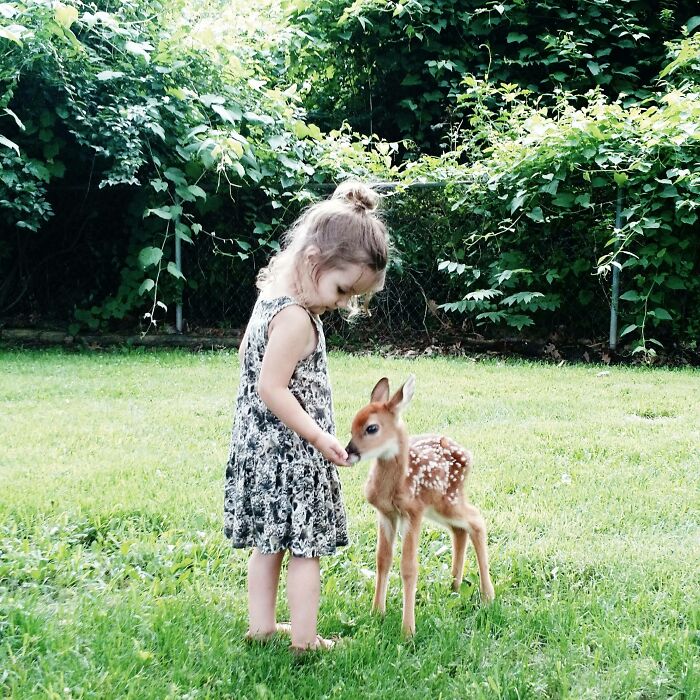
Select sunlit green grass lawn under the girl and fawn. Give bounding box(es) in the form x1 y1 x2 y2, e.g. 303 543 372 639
0 351 700 700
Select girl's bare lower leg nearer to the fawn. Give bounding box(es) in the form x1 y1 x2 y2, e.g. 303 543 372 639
287 556 321 649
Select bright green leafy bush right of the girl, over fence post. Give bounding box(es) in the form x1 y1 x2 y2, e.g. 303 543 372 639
426 31 700 350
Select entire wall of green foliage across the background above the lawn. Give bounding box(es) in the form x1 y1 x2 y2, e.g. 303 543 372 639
0 0 700 353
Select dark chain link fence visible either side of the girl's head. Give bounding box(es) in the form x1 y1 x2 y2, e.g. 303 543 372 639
178 186 462 346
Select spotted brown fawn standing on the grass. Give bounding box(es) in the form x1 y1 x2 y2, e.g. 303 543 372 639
346 375 494 635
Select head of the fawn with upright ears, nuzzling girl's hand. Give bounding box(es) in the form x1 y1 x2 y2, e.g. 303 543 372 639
345 374 416 464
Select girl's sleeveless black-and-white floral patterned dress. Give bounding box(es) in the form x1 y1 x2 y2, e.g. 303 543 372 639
224 297 348 557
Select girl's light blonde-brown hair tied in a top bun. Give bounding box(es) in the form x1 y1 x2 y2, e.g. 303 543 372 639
256 180 390 314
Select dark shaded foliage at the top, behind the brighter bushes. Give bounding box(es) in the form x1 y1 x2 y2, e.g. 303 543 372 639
290 0 697 152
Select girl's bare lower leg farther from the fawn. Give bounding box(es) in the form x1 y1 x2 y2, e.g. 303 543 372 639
248 547 285 638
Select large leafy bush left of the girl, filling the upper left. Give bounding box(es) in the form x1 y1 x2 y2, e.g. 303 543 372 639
0 0 388 327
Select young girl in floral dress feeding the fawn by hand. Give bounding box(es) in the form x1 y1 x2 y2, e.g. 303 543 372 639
224 182 389 650
